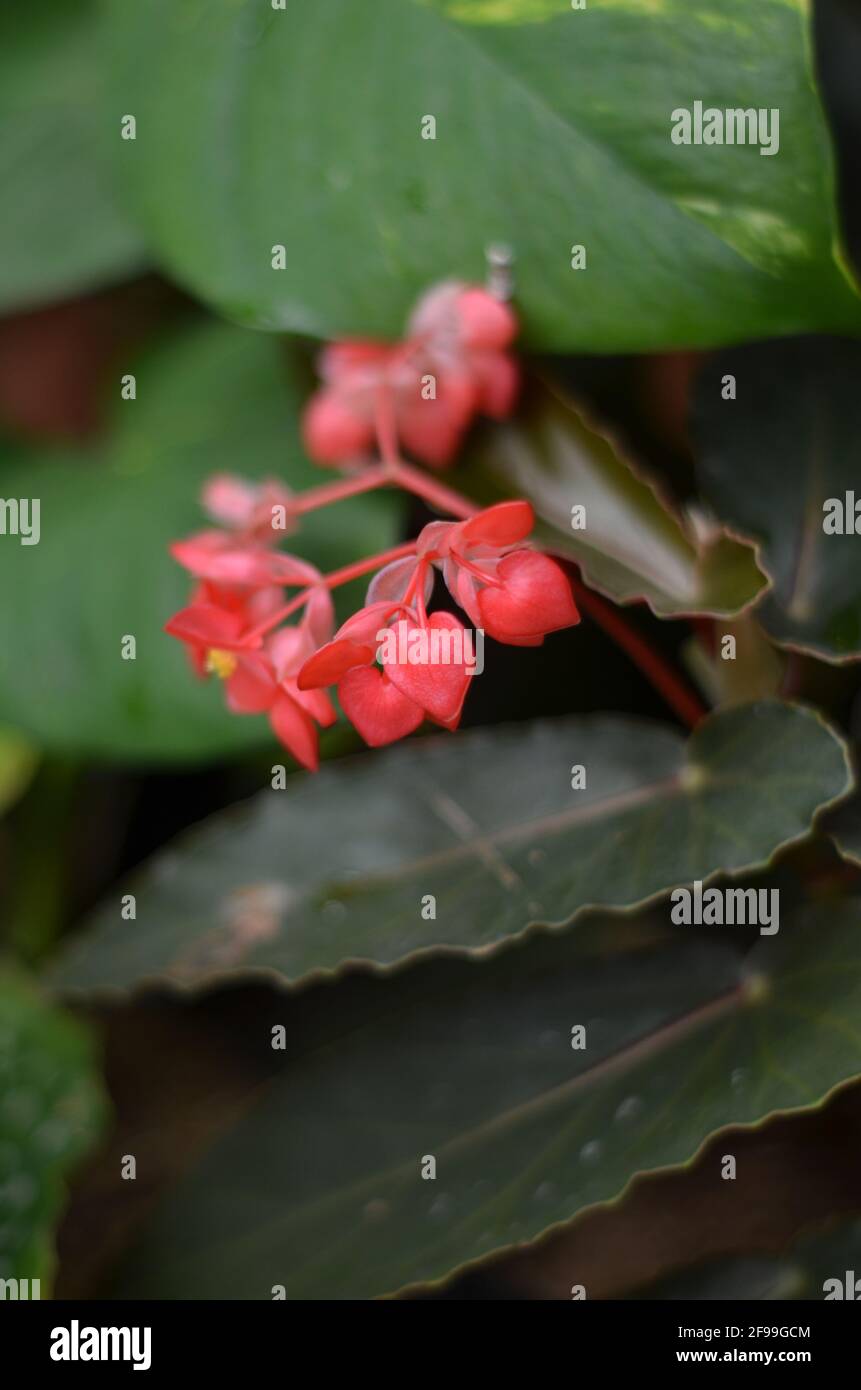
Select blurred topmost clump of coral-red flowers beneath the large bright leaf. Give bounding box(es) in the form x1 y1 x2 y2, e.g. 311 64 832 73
303 284 519 467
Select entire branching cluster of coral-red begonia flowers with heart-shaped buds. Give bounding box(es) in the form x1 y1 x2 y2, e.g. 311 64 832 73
167 276 579 769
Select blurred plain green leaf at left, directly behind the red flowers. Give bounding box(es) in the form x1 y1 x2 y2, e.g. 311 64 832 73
0 322 398 760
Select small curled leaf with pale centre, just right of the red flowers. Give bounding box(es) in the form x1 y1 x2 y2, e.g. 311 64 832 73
459 384 766 617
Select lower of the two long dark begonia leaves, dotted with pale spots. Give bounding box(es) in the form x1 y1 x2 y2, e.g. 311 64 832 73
97 901 861 1300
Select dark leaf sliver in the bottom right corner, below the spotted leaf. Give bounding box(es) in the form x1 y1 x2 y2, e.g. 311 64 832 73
633 1220 861 1302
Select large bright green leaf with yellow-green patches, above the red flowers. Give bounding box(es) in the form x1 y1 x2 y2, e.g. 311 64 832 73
97 0 861 352
